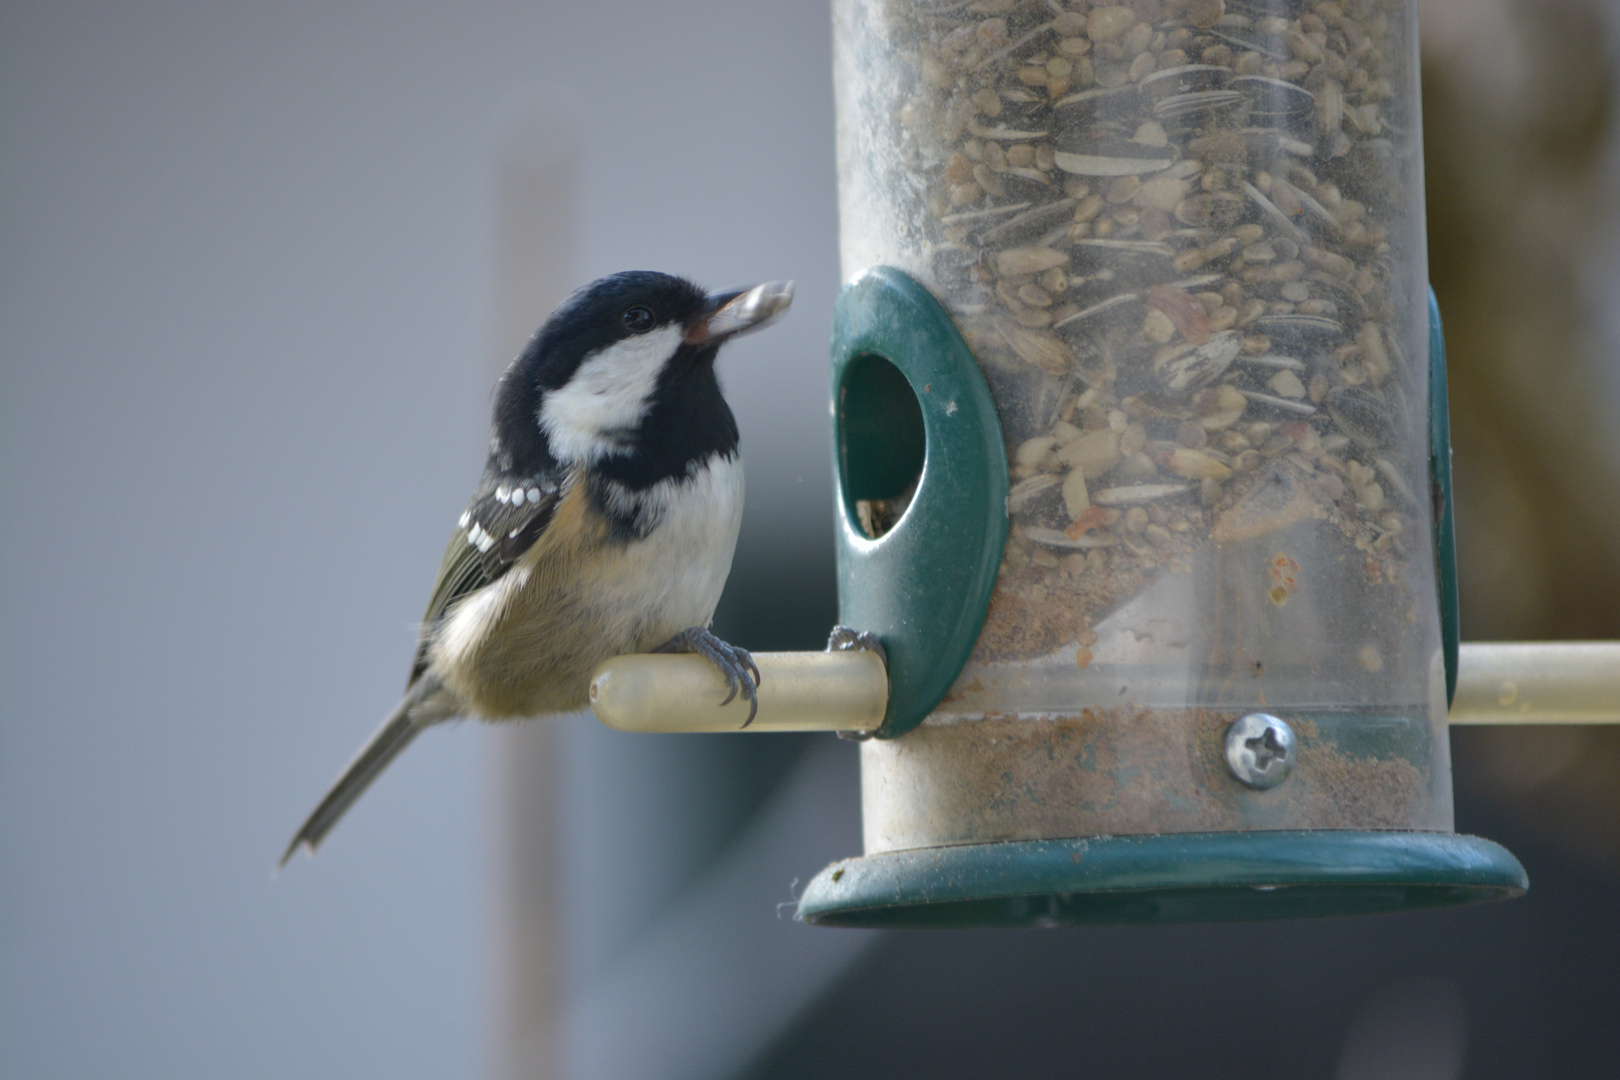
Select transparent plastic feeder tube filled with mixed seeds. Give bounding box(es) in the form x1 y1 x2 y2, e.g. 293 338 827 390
833 0 1452 853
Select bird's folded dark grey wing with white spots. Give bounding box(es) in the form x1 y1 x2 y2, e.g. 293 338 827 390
407 473 570 687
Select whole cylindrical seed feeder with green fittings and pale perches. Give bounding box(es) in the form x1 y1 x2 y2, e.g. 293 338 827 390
593 0 1615 926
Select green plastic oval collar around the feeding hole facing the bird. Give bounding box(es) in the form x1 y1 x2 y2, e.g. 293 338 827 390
833 267 1008 738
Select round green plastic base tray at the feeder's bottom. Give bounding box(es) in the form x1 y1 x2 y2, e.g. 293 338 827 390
799 831 1529 928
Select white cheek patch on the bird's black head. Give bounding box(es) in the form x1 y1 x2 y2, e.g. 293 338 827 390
538 325 682 461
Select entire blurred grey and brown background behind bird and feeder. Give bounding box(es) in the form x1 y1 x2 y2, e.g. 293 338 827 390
9 0 1620 1080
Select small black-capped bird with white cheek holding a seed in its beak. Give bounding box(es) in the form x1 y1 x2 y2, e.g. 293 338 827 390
279 270 794 866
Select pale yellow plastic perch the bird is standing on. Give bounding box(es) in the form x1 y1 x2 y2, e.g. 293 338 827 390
591 651 889 733
